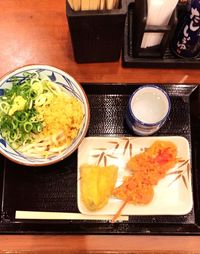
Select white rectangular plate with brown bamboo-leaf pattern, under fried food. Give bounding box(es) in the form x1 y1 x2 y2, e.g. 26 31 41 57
77 136 193 215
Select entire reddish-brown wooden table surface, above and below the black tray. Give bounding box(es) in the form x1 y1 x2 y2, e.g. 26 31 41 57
0 0 200 253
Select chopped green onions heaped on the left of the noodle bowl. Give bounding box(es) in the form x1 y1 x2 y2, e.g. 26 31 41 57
0 72 59 148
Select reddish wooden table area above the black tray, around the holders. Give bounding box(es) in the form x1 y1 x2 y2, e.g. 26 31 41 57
0 0 199 83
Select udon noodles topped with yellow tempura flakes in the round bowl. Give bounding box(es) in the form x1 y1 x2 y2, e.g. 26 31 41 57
0 71 84 158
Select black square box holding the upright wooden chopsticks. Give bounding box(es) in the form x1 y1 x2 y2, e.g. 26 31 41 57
66 0 127 63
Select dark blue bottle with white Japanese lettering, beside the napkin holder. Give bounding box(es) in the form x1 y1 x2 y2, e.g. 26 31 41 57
171 0 200 58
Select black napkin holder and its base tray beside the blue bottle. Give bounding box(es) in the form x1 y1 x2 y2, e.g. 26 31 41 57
122 0 200 69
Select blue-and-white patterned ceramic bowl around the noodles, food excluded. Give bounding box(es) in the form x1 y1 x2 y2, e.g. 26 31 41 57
0 65 90 166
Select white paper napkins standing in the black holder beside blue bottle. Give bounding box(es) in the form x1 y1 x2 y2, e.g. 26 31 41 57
141 0 178 48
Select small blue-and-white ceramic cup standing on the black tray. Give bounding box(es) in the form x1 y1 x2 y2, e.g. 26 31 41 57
126 85 171 136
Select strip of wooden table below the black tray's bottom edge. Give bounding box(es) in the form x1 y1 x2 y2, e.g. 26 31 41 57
0 235 200 254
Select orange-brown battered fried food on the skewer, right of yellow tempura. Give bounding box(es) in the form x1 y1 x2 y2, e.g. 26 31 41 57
113 140 177 208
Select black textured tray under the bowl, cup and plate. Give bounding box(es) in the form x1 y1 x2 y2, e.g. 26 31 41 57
0 84 200 235
